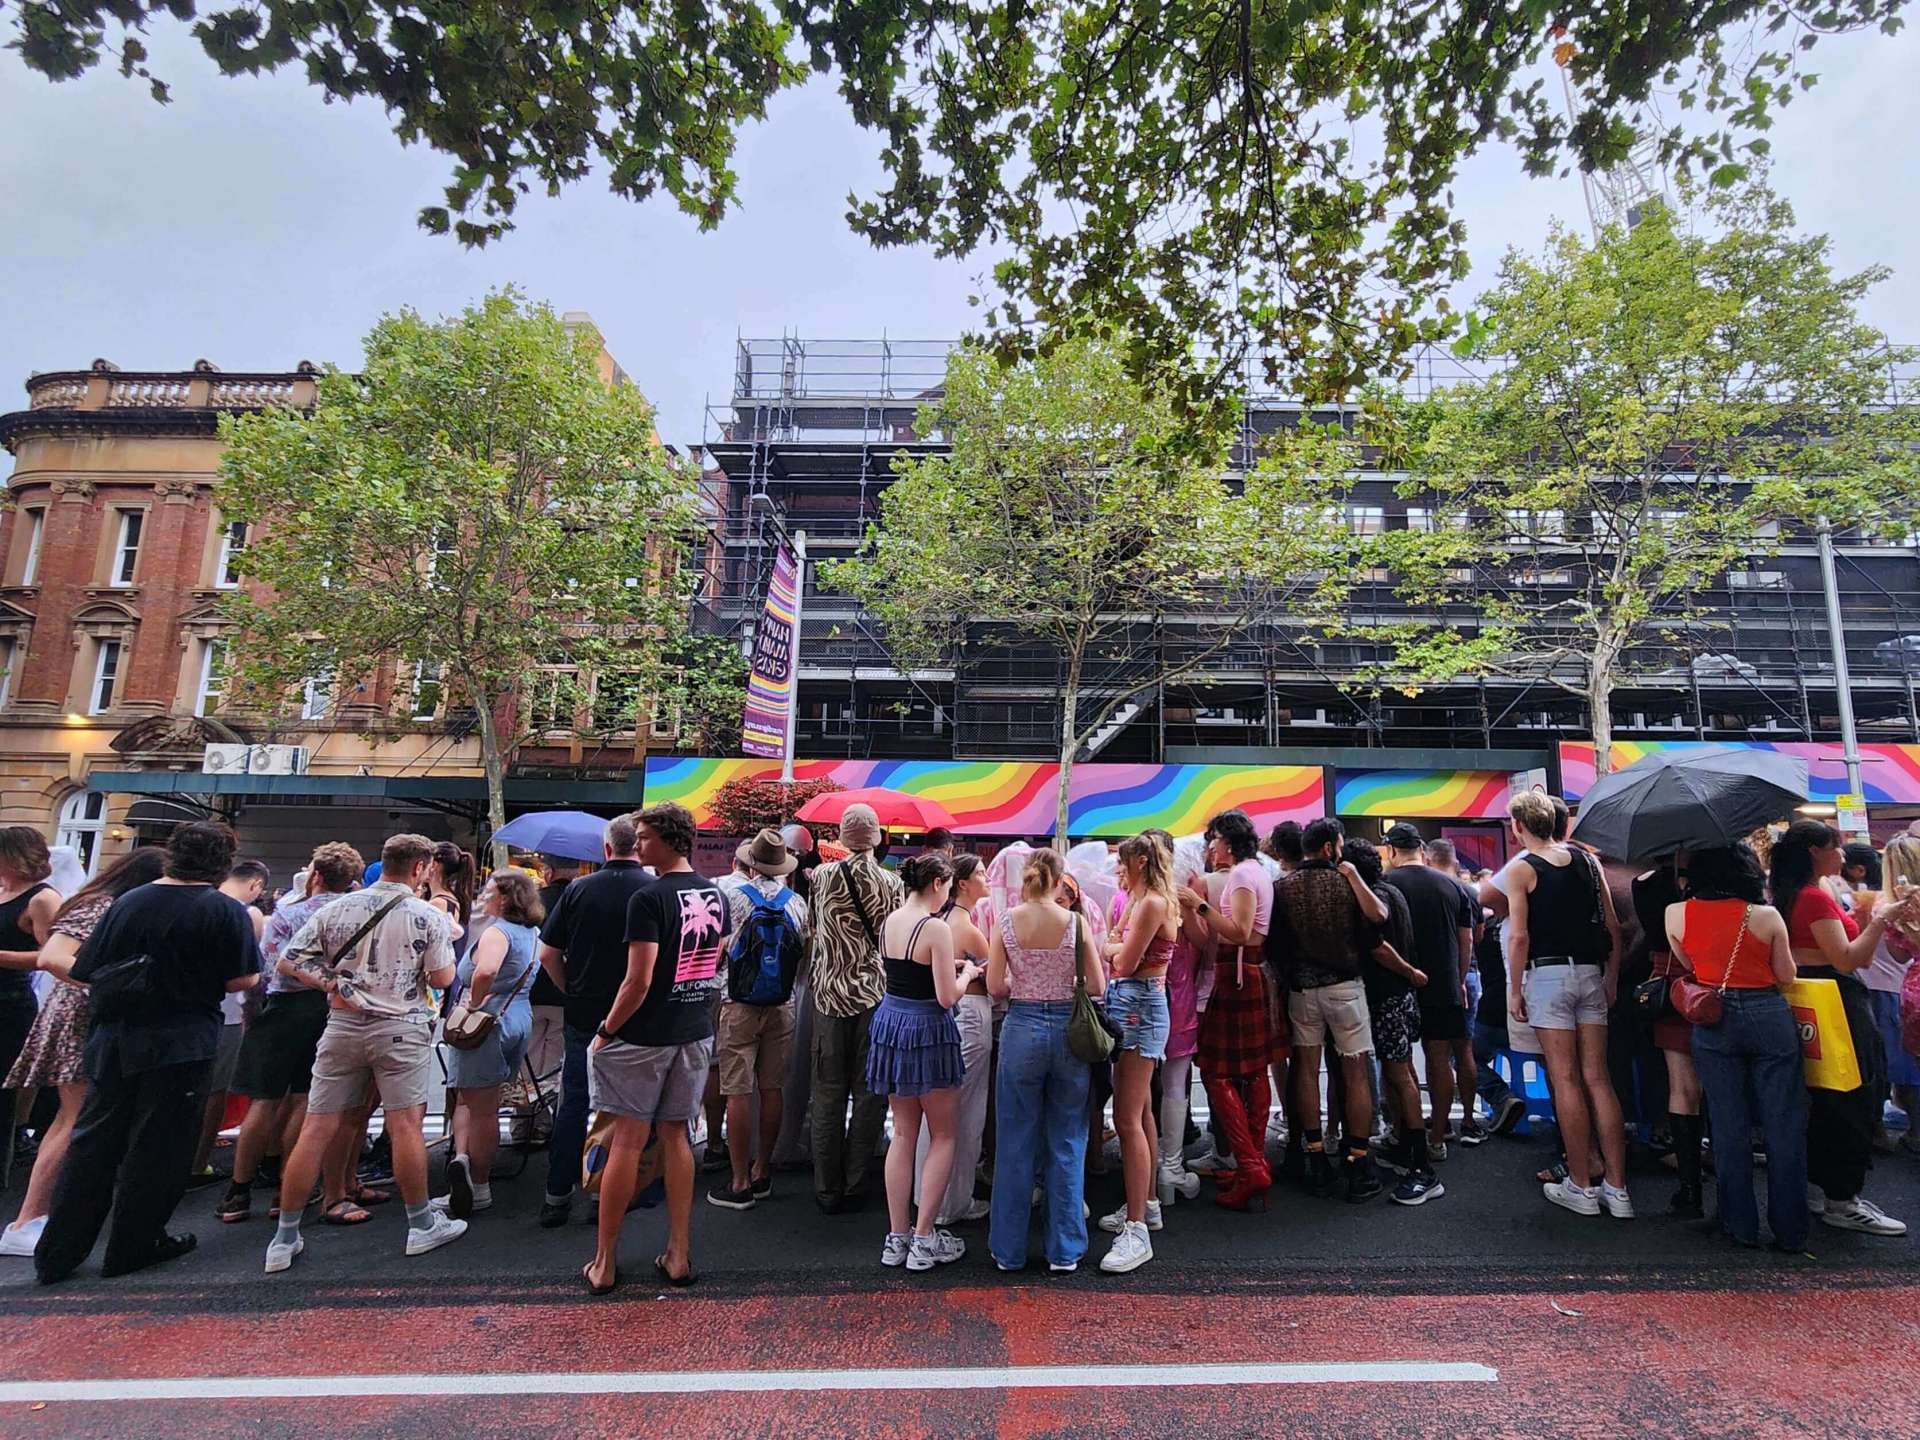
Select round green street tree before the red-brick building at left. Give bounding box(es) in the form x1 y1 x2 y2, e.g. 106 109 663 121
206 292 721 840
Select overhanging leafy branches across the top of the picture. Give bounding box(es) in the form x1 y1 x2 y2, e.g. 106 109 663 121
11 0 1905 397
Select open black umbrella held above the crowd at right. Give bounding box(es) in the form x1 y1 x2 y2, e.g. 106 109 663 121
1572 745 1807 860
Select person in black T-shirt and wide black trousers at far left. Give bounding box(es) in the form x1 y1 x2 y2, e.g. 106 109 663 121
33 820 259 1284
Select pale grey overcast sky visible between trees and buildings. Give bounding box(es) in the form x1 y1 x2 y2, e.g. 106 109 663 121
0 29 1920 442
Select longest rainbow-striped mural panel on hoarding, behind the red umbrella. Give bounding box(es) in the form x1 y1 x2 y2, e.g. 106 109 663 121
645 756 1327 837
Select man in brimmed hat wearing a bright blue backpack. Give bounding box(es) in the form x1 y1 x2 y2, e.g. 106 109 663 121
707 829 808 1210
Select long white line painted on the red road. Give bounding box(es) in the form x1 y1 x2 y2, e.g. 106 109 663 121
0 1359 1500 1405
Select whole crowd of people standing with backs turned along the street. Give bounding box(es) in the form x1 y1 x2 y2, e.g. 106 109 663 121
0 791 1920 1294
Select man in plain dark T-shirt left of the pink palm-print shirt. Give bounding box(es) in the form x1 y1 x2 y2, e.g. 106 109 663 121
540 814 653 1231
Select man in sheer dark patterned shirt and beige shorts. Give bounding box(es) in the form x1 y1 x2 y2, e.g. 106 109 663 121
1274 818 1388 1204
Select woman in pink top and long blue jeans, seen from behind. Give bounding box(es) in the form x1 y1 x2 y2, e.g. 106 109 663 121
987 849 1106 1275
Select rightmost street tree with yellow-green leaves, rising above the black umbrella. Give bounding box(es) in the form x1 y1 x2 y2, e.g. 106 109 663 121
1377 184 1920 768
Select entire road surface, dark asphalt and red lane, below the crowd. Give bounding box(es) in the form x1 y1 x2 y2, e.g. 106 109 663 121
0 1140 1920 1438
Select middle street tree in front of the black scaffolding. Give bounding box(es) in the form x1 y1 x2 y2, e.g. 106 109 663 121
822 342 1354 824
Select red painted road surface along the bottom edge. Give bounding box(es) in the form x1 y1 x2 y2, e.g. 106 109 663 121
0 1271 1920 1440
